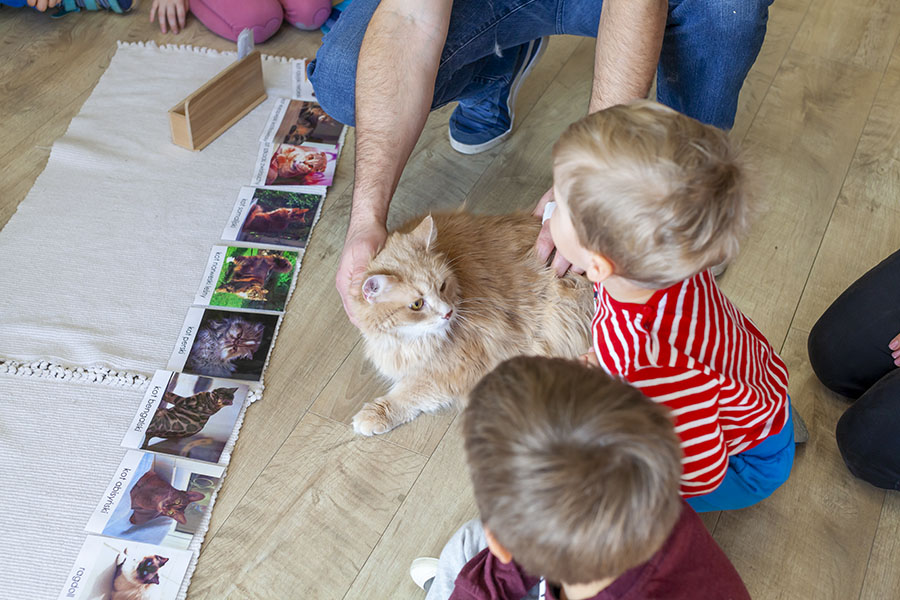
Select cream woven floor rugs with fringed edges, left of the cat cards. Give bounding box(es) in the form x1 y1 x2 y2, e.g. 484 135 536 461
0 43 306 598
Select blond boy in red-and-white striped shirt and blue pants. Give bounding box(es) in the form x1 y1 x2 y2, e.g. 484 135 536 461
550 101 794 511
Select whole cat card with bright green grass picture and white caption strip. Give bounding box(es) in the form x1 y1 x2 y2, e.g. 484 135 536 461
194 246 298 312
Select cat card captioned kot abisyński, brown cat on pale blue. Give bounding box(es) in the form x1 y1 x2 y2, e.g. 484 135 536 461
85 450 225 550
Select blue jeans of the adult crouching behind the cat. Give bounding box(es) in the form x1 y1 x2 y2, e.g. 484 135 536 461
308 0 773 129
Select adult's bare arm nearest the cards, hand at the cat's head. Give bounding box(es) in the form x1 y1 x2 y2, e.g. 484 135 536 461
335 0 453 323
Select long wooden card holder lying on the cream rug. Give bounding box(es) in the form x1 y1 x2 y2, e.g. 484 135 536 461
169 51 267 150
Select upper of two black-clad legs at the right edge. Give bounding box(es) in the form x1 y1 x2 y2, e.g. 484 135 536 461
808 251 900 398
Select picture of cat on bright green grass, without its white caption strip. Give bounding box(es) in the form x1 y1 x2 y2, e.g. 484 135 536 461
209 246 297 311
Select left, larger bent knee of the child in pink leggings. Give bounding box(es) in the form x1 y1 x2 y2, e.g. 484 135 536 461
191 0 284 44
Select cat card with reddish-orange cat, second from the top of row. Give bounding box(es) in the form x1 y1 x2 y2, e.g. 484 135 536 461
250 142 338 187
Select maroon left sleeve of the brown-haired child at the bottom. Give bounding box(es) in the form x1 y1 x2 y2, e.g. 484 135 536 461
450 548 540 600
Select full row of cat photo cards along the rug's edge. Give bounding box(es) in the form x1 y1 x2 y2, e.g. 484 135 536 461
59 60 345 600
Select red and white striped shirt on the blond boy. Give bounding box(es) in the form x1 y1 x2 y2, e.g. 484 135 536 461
592 271 789 496
